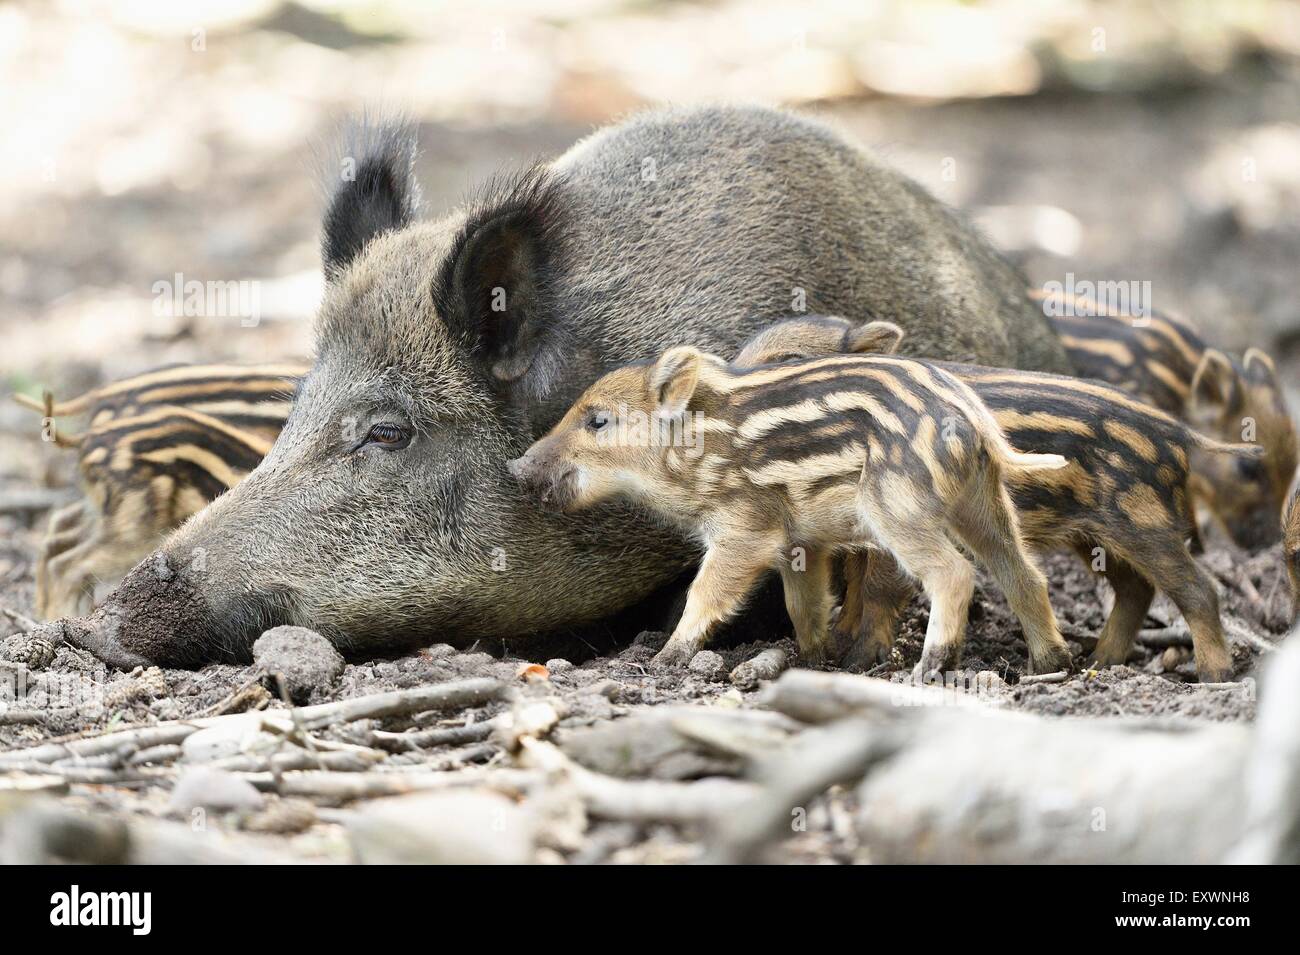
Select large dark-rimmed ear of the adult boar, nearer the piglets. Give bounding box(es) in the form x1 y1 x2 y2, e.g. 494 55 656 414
433 166 562 391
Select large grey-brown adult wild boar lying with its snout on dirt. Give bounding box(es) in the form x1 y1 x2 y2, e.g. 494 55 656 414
78 107 1066 665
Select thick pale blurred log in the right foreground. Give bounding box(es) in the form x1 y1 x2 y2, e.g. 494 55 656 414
857 691 1251 864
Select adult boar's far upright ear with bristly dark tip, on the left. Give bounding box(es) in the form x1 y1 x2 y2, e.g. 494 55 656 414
321 117 420 278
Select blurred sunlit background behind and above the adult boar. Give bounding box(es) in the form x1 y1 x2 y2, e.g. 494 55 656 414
0 0 1300 475
